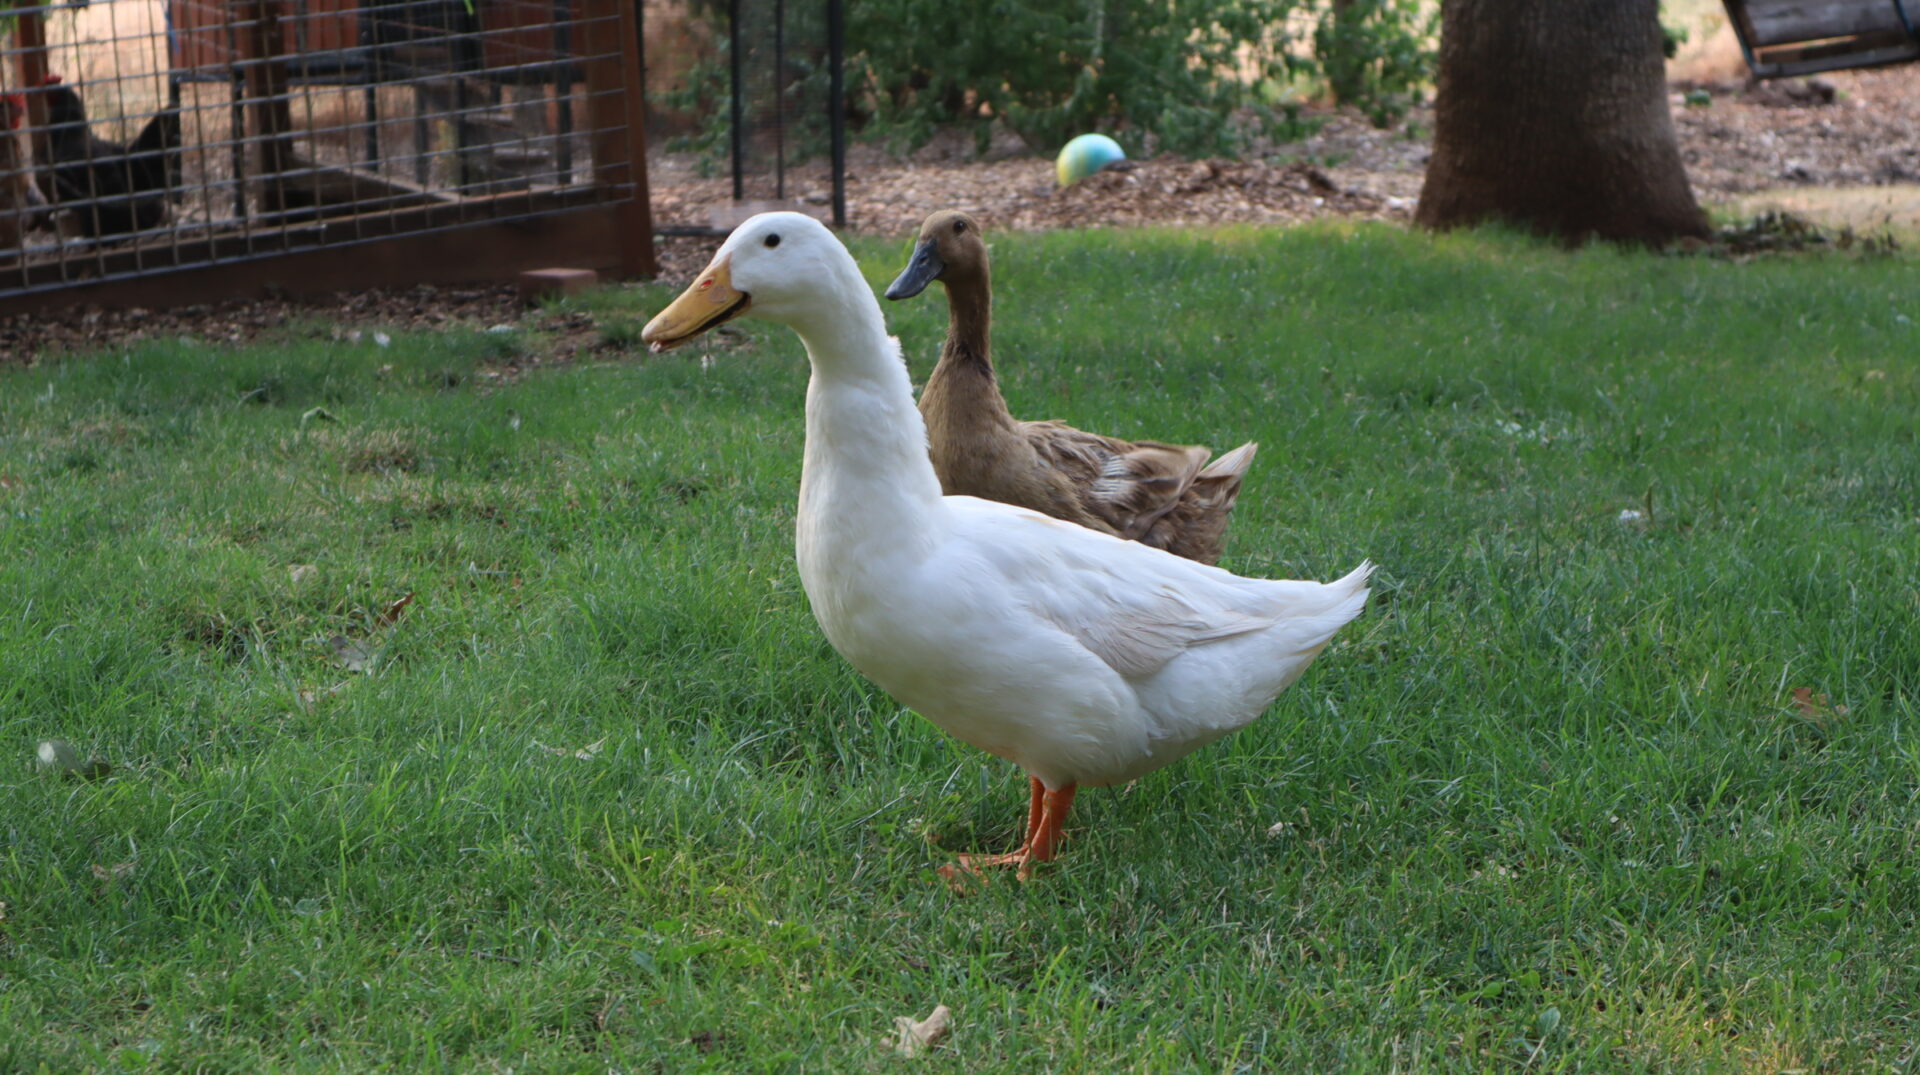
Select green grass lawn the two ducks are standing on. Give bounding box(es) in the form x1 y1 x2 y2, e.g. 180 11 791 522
0 228 1920 1073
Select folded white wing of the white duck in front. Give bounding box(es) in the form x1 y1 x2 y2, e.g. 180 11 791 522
947 497 1365 680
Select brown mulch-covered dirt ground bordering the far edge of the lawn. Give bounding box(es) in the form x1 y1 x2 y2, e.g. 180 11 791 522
0 46 1920 361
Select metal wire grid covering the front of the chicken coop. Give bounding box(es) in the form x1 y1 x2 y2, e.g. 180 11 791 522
0 0 634 296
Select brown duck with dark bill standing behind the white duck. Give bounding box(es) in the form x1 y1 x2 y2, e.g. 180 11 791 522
887 209 1256 564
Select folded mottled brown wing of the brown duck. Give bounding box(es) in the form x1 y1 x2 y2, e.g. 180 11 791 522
1020 422 1208 541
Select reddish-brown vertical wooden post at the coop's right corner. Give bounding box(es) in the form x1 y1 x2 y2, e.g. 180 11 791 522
578 0 659 276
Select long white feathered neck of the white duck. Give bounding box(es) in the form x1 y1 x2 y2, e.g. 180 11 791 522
793 270 941 561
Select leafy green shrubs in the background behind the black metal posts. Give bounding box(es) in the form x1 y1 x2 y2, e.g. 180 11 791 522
666 0 1432 161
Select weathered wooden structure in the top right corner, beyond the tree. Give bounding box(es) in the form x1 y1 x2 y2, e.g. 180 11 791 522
1726 0 1920 79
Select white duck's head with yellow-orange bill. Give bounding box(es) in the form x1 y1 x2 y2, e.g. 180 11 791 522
639 213 874 351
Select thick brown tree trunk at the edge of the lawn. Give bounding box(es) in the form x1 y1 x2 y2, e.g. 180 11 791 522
1413 0 1707 244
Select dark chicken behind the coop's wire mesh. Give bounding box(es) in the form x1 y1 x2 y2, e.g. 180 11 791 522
44 75 180 238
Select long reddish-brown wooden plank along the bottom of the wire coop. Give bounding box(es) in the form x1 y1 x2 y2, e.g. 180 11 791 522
0 205 622 317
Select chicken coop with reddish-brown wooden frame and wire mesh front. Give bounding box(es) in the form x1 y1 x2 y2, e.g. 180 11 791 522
0 0 653 311
